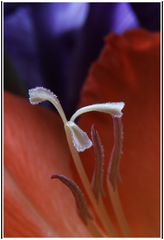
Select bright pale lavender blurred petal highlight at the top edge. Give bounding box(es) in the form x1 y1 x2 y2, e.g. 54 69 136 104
35 2 89 37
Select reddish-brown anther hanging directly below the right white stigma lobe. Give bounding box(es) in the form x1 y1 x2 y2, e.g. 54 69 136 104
109 118 123 191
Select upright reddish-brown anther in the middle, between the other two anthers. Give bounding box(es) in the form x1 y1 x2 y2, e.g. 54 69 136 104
91 125 104 201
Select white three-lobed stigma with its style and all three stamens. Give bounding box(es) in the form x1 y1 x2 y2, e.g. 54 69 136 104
29 87 130 237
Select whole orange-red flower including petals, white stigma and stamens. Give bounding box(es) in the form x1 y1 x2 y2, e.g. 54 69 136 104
4 30 160 237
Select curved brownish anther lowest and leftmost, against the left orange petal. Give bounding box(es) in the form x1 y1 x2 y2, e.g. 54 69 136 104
51 174 92 224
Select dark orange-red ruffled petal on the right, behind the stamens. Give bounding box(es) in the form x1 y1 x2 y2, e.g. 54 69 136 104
80 29 160 237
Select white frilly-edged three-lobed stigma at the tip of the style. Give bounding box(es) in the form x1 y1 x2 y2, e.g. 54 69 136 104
29 87 125 152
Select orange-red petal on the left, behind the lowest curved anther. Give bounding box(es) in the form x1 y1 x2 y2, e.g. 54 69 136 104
4 93 89 237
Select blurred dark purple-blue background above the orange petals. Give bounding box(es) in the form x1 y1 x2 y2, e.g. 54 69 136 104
3 2 160 116
